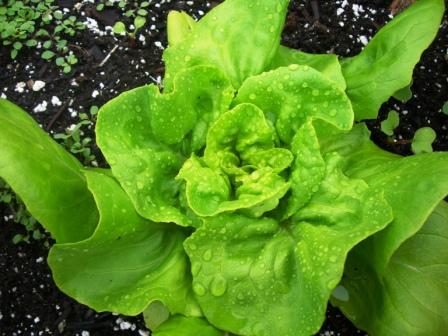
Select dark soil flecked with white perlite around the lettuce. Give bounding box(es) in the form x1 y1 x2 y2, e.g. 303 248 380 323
0 0 448 336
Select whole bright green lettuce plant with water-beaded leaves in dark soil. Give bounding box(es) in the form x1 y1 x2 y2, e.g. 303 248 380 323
0 0 448 336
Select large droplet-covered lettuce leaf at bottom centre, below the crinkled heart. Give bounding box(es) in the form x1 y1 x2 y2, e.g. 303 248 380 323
184 155 392 336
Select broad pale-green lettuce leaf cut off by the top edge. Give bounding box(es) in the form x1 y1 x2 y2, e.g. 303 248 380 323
163 0 289 90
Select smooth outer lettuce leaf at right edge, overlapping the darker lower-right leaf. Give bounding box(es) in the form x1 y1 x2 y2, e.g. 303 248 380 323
345 142 448 272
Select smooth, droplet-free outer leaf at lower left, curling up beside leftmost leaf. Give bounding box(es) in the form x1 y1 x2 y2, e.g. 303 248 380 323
48 172 201 316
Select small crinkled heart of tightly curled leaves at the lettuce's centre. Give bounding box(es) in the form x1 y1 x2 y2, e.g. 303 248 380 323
178 104 293 216
